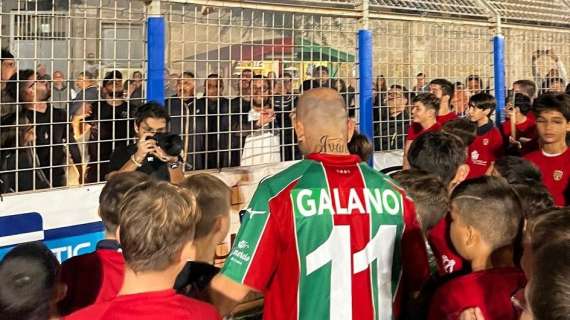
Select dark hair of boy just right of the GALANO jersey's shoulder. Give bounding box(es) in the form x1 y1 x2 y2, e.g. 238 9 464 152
408 132 467 186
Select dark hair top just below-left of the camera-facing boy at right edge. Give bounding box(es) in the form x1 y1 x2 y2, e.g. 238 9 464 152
493 156 542 186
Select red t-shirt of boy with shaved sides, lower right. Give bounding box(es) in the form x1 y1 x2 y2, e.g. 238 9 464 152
428 268 526 320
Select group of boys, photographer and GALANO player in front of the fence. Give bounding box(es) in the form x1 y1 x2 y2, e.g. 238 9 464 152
0 85 570 320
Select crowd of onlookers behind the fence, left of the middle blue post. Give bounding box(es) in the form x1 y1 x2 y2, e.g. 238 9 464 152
0 45 355 193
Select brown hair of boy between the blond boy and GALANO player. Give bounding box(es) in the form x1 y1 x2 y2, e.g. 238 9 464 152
180 173 232 239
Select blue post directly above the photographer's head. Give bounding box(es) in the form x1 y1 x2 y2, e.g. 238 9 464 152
146 16 165 105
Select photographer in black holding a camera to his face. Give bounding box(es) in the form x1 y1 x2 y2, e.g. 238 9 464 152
109 102 184 184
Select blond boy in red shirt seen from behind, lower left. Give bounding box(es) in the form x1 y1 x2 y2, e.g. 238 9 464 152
67 181 220 320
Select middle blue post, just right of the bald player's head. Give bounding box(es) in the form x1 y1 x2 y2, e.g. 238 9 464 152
358 29 374 166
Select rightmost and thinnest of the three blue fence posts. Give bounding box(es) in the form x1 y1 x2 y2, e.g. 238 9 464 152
493 34 507 126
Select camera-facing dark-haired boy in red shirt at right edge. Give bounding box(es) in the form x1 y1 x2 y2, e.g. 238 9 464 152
525 93 570 207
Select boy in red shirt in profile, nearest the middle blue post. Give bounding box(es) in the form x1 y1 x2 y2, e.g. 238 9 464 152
403 93 441 169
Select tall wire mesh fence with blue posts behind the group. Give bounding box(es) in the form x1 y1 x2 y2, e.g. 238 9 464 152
0 0 570 193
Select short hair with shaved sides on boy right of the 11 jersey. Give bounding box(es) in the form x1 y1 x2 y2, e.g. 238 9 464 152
451 176 522 250
